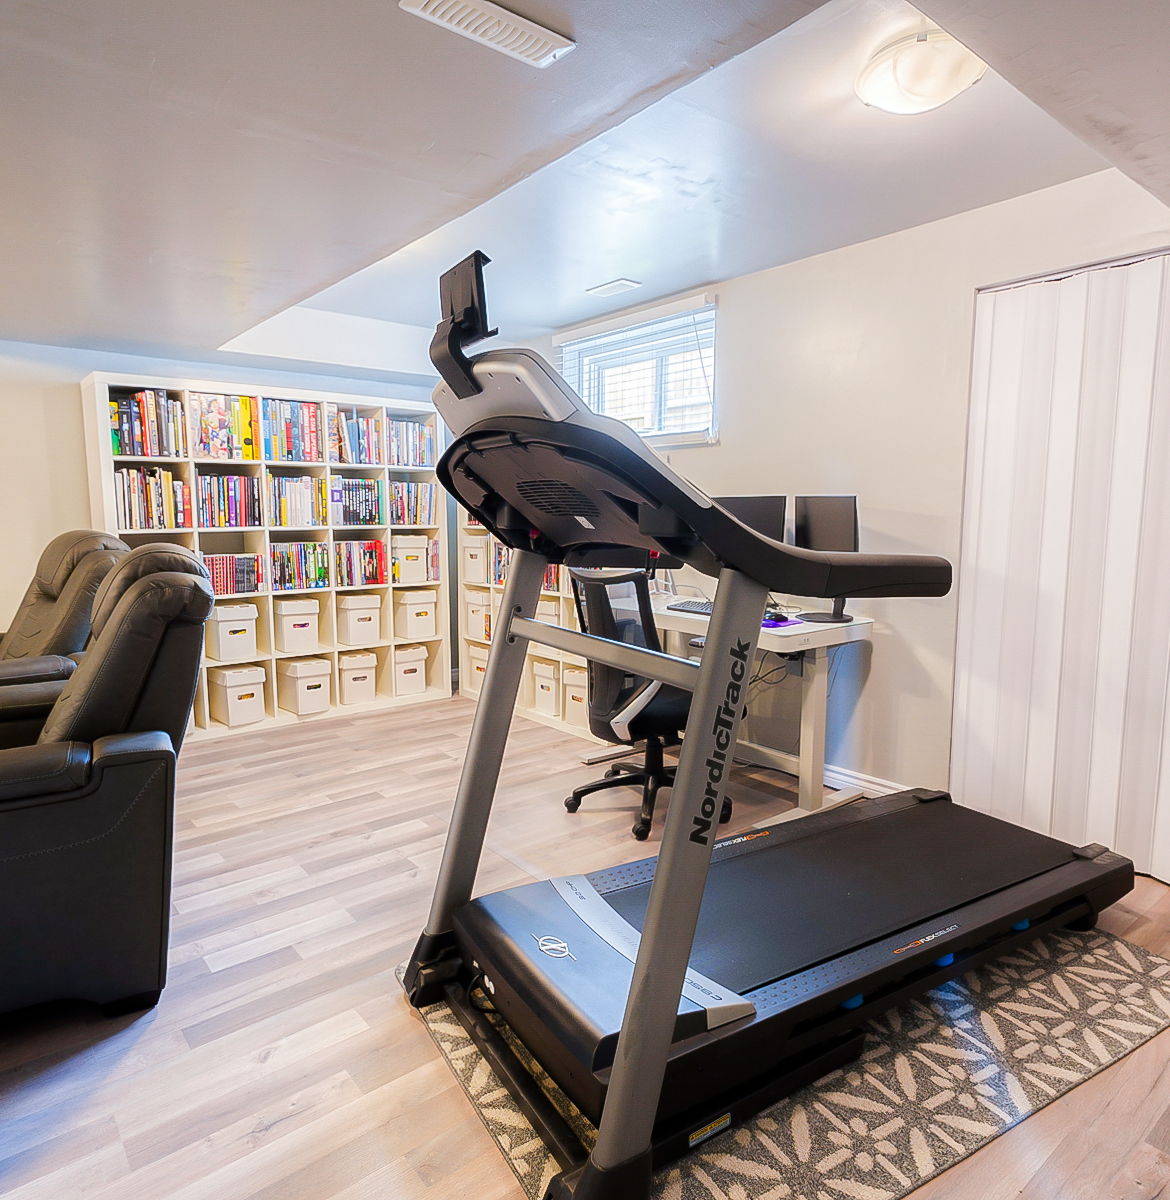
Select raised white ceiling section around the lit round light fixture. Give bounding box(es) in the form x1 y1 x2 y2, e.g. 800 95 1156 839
292 0 1108 347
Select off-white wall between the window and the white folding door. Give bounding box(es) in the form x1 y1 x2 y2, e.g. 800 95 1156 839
670 170 1170 786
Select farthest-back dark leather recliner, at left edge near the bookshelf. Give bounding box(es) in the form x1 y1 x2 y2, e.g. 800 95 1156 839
0 529 130 684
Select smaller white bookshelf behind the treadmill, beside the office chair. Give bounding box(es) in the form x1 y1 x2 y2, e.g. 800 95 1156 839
457 523 604 745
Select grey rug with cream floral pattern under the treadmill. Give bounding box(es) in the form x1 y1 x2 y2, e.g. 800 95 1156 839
410 932 1170 1200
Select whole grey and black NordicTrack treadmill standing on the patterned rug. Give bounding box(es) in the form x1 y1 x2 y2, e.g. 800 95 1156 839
403 252 1133 1200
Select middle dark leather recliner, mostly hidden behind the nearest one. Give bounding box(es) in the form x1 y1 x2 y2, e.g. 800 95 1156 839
0 542 208 752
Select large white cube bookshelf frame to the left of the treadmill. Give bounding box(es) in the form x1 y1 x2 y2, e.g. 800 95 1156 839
82 373 451 738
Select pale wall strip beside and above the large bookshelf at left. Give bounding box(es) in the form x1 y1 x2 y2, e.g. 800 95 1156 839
0 341 430 629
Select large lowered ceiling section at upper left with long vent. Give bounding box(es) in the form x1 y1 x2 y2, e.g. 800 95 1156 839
0 0 817 354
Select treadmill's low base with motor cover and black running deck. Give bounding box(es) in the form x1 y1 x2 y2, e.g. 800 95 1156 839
455 791 1133 1120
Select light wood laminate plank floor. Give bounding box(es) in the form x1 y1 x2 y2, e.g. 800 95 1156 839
0 700 1170 1200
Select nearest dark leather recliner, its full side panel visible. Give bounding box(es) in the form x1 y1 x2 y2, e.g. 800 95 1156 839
0 546 212 1012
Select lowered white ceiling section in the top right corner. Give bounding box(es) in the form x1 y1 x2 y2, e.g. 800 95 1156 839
919 0 1170 204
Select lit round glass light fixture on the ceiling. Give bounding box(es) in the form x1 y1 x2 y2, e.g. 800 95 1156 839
853 29 988 114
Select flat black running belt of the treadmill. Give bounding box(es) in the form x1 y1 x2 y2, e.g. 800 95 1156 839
605 802 1073 995
